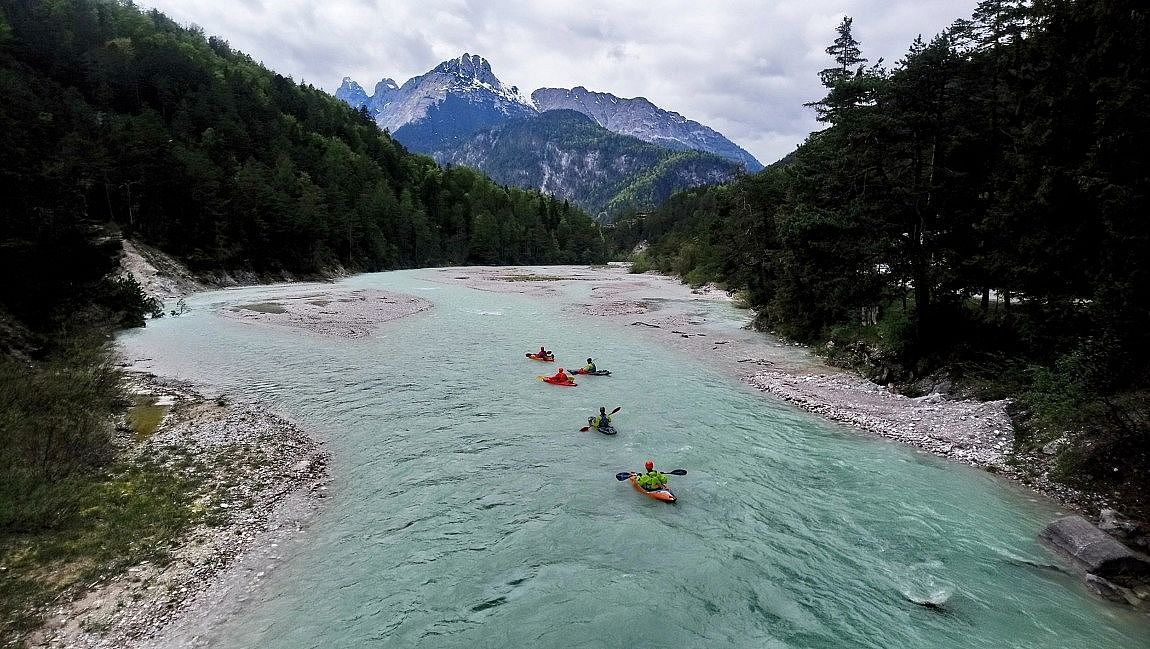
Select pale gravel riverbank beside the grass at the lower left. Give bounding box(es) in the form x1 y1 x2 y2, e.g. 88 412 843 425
24 373 331 648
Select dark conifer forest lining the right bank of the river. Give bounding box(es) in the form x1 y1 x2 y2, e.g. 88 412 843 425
613 0 1150 506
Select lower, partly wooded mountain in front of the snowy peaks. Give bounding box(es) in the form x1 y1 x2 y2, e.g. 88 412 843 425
435 110 741 214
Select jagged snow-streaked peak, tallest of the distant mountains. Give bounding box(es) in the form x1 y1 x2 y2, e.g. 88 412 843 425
336 54 536 153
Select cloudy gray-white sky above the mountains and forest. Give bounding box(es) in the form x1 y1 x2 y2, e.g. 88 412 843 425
137 0 976 163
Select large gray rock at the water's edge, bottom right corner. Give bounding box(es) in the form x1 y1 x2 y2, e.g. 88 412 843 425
1038 516 1150 587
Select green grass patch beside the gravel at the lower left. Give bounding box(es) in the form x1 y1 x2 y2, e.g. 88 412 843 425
0 458 214 647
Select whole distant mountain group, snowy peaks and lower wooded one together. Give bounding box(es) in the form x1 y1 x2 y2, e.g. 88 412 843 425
336 54 762 213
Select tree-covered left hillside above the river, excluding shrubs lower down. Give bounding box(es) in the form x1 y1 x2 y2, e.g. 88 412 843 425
0 0 605 285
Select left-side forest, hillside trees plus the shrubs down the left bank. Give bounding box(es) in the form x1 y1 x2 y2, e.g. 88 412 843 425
0 0 607 532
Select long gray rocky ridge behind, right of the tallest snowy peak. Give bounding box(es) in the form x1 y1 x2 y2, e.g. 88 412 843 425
531 86 762 173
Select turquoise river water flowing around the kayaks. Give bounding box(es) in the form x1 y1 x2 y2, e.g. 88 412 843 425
121 270 1150 649
